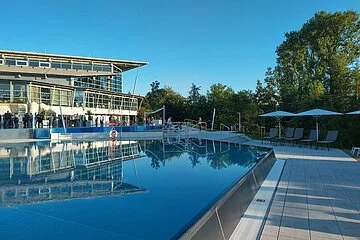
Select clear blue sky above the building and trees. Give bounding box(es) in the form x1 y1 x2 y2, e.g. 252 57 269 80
0 0 360 95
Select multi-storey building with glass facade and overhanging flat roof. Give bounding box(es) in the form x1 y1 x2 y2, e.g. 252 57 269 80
0 50 147 123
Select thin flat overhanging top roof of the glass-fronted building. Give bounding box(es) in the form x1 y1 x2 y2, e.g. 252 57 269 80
0 50 148 72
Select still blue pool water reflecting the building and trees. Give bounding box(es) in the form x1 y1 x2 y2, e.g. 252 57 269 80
0 140 268 240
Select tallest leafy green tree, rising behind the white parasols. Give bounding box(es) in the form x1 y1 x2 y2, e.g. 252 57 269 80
275 11 360 111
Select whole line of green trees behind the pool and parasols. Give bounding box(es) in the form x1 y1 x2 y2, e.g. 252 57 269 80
139 11 360 147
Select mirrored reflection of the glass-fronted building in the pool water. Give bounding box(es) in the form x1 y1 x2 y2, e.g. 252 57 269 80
0 141 144 206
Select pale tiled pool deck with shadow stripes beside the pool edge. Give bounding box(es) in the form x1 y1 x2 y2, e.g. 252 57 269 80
248 141 360 240
